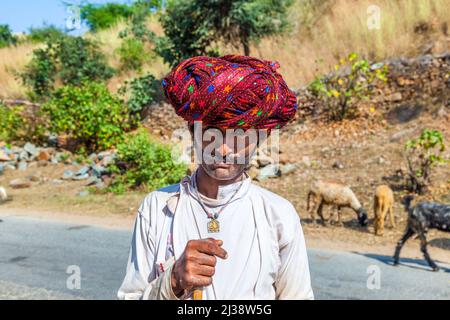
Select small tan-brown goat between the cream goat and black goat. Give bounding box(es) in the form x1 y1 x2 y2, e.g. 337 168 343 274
373 185 395 236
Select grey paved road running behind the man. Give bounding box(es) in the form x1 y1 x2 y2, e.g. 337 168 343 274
0 217 450 299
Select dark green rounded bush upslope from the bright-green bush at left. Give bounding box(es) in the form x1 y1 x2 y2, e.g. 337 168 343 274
21 37 114 98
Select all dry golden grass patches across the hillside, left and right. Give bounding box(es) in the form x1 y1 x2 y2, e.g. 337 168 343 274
0 0 450 98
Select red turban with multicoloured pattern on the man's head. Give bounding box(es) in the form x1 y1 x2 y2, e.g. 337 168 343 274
162 55 298 130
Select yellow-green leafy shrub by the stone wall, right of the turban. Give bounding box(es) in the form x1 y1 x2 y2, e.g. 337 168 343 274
309 53 388 120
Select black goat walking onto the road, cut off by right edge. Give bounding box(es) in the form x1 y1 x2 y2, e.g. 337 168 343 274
394 195 450 271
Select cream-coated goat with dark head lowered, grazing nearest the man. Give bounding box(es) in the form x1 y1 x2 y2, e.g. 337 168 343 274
307 180 367 226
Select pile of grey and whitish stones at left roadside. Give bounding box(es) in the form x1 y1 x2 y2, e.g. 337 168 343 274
0 142 116 189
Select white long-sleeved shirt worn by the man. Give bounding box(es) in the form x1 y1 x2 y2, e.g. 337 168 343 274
118 171 314 300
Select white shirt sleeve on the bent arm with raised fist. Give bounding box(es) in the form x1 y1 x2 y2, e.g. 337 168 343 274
117 196 178 300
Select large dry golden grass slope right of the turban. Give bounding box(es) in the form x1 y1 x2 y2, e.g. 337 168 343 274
243 0 450 88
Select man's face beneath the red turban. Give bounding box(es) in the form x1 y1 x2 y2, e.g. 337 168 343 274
193 126 259 180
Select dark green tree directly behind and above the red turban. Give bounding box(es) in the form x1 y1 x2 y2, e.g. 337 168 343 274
157 0 293 66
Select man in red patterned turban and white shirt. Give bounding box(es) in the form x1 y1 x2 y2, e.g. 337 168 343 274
118 56 313 299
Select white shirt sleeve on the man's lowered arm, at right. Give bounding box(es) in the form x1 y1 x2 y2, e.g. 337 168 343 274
275 206 314 300
